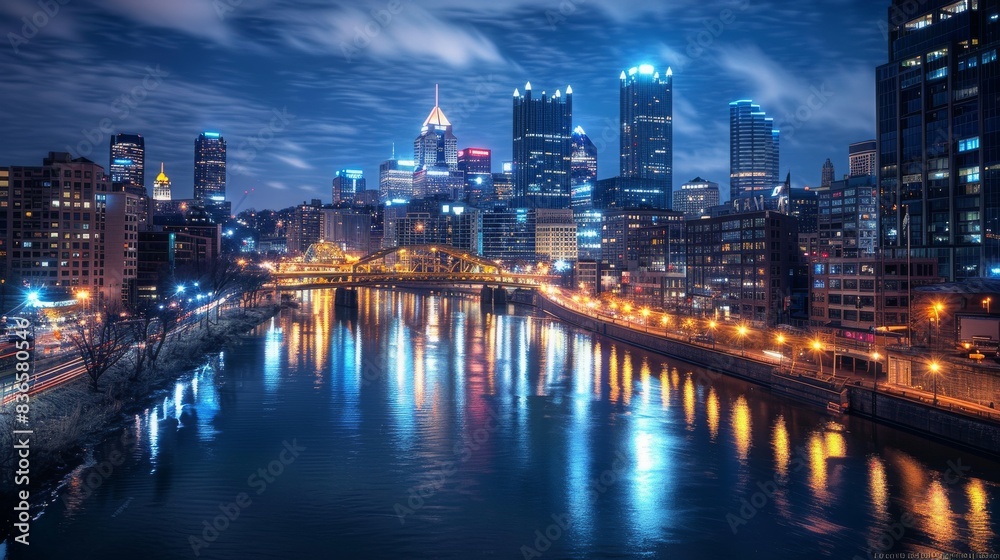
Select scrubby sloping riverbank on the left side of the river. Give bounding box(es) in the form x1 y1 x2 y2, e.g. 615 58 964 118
0 306 279 500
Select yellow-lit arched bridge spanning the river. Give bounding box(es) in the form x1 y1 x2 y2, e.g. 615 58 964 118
271 242 558 291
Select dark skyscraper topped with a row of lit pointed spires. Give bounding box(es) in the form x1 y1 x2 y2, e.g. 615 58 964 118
513 82 573 208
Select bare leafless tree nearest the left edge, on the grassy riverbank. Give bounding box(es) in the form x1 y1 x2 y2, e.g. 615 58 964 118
69 301 134 391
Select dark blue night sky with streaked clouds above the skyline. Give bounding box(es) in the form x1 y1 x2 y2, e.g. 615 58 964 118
0 0 889 210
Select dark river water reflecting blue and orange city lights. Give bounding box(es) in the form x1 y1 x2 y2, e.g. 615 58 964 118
18 291 1000 559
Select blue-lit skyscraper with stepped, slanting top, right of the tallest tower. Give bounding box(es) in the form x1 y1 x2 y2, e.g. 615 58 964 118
729 100 779 200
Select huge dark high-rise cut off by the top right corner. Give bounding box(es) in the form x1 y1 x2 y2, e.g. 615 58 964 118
876 0 1000 281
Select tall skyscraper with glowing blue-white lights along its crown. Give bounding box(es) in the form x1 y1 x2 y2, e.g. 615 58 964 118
619 64 674 192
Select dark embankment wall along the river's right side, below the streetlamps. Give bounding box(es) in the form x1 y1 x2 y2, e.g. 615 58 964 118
535 294 1000 459
